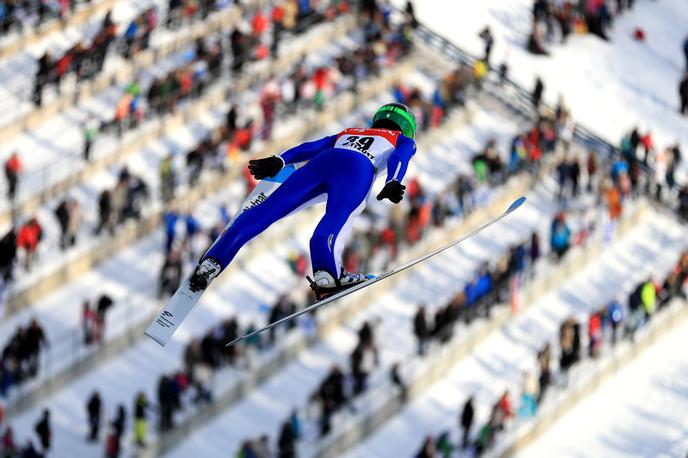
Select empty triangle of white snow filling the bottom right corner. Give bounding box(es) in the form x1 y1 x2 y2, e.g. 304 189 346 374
518 314 688 458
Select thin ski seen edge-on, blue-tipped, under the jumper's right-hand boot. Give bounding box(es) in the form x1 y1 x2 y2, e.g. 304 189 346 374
225 197 526 347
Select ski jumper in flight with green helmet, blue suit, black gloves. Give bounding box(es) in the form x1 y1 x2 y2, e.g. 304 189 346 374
190 103 416 298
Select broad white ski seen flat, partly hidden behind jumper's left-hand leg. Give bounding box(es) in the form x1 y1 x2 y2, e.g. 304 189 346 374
144 165 296 347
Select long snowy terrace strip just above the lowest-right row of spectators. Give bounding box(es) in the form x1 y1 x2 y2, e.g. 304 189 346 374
348 211 686 458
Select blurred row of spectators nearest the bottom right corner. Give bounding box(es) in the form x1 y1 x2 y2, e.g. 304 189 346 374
416 247 688 458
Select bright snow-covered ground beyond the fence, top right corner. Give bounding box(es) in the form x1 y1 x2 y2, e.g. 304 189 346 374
394 0 688 180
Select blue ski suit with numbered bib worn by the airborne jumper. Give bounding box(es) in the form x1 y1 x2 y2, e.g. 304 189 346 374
202 128 416 278
